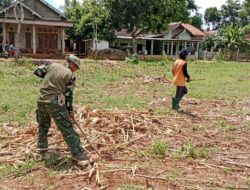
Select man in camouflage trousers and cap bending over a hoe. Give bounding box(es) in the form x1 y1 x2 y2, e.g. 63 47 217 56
34 55 88 161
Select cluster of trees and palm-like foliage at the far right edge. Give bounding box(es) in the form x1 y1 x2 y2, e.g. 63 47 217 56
203 0 250 56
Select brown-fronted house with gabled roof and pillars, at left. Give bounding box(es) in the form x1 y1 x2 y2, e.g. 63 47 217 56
0 0 73 54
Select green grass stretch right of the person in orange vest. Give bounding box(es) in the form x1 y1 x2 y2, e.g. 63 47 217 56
188 62 250 100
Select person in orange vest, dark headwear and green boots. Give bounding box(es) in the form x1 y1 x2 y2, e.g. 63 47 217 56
172 49 191 110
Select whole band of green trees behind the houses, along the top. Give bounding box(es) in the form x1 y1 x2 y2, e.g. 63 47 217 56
0 0 250 55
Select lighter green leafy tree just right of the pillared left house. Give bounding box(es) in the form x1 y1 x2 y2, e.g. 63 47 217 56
66 0 114 40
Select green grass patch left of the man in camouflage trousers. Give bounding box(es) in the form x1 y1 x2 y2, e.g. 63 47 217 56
0 61 40 124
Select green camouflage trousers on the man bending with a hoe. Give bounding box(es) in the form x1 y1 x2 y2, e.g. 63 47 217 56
36 98 84 157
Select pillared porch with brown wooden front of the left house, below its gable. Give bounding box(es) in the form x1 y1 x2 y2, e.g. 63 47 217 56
0 19 72 55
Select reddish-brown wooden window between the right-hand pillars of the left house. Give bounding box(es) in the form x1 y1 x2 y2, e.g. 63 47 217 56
38 33 58 49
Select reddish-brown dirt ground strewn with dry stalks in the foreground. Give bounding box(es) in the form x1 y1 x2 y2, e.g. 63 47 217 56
0 95 250 190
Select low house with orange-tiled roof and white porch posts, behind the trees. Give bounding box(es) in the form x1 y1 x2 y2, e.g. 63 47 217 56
111 22 206 56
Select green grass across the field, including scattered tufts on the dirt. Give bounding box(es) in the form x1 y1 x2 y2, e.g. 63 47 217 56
0 59 250 186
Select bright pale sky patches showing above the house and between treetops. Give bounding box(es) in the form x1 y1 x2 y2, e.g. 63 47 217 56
46 0 243 14
